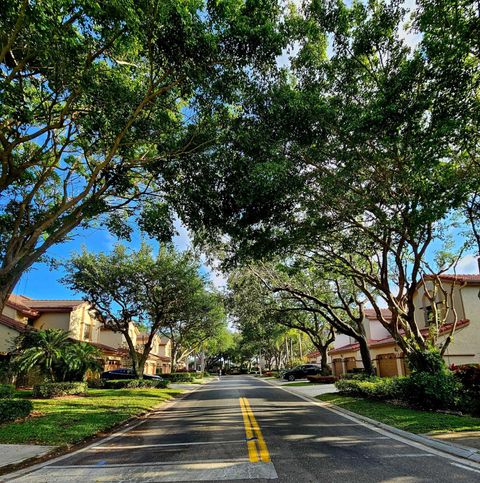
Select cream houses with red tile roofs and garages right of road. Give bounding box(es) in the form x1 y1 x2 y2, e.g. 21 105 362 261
329 275 480 377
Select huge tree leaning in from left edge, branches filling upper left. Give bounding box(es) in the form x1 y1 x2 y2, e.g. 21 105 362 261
0 0 285 310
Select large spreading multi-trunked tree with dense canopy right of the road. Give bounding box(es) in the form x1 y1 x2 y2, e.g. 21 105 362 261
164 1 478 374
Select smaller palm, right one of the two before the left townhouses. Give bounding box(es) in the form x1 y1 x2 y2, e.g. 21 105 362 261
63 341 102 381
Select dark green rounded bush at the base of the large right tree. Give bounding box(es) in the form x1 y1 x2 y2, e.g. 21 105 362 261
405 371 461 409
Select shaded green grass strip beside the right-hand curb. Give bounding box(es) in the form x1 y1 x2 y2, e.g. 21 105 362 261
316 393 480 434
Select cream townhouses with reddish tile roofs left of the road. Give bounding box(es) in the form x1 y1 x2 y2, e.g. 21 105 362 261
0 294 171 374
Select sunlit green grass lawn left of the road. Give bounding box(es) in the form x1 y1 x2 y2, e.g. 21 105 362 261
0 389 182 446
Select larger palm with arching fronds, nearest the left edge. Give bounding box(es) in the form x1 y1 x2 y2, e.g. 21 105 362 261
14 329 70 381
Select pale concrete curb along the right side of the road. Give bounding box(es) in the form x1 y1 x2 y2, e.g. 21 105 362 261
258 380 480 463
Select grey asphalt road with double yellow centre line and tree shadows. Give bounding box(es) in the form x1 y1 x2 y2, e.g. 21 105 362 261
6 376 480 483
